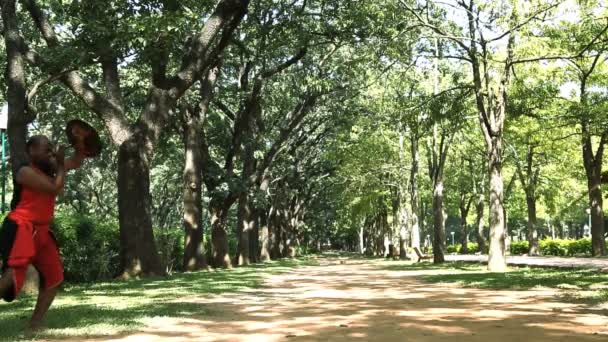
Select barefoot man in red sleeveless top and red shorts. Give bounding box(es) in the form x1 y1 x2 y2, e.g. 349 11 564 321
0 135 85 331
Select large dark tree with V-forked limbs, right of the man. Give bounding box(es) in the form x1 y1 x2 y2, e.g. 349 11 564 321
3 0 248 276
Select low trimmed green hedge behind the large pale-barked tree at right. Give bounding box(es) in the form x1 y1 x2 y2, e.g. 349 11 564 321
511 239 592 256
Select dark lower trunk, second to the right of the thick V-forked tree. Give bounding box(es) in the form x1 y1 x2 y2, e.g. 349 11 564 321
209 202 231 268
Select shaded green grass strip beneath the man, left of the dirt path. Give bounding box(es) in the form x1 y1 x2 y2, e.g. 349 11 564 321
0 259 317 341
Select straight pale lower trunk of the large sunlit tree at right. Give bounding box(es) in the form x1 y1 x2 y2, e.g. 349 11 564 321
488 136 507 272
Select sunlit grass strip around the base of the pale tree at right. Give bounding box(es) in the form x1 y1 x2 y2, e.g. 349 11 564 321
384 262 608 304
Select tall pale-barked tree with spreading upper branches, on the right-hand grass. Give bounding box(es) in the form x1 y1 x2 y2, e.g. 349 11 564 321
401 0 559 272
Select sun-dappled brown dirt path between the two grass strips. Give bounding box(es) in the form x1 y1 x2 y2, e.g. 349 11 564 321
59 259 608 342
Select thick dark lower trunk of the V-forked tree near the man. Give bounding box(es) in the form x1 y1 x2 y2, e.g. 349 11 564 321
117 137 165 278
